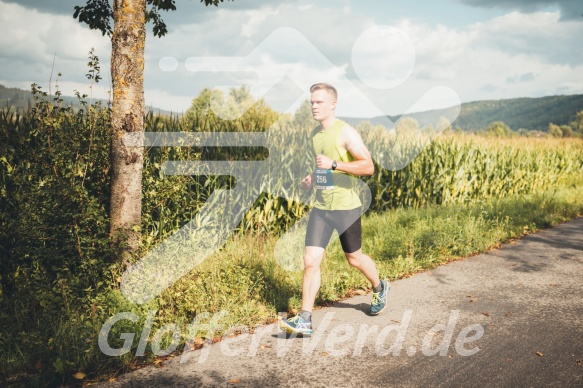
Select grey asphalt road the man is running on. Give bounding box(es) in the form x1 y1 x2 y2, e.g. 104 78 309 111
103 218 583 387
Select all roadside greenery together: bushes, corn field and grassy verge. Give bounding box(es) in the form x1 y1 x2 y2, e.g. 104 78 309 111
0 79 583 385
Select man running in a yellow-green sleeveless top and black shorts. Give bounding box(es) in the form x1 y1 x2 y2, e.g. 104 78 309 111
280 83 390 335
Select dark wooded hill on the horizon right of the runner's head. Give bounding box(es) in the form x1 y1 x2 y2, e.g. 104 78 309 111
343 94 583 131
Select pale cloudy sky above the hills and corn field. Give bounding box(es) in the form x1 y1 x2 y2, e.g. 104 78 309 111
0 0 583 117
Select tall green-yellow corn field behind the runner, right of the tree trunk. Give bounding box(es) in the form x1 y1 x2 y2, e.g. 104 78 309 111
136 112 583 246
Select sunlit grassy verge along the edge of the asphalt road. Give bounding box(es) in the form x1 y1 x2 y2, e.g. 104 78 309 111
4 179 583 385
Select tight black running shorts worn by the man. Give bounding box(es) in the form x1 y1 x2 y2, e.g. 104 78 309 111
306 207 362 253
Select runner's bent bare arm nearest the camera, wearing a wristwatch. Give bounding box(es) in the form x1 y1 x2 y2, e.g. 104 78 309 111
316 125 374 176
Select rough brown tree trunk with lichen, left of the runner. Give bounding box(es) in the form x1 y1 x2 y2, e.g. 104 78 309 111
110 0 146 265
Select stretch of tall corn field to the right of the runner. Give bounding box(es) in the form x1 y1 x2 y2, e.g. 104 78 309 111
367 135 583 211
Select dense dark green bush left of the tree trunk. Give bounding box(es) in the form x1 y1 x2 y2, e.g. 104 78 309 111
0 85 116 382
